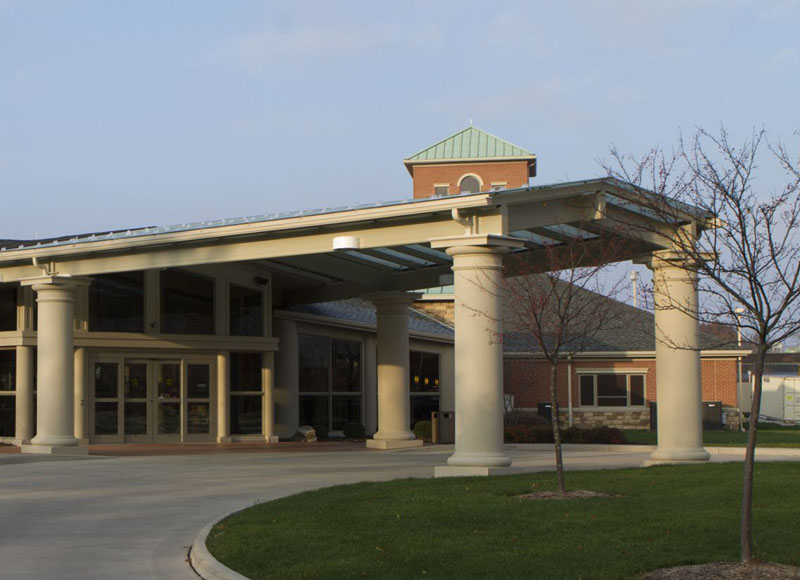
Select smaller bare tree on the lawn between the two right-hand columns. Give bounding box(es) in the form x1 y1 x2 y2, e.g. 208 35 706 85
504 239 636 493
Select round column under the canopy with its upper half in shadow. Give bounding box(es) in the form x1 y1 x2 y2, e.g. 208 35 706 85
365 292 422 449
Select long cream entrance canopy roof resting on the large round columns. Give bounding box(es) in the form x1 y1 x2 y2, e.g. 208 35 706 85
0 178 702 306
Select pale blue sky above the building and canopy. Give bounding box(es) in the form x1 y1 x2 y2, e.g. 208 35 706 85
0 0 800 239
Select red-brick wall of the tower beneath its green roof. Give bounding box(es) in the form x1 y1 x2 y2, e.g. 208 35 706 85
411 161 528 198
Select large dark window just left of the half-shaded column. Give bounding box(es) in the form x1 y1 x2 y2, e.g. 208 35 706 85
299 334 362 431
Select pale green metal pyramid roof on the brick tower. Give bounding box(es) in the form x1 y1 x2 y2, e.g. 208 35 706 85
404 126 534 163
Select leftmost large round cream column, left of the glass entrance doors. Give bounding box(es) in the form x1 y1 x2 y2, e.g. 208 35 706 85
22 276 89 454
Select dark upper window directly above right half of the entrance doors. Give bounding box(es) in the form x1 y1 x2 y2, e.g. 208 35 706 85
161 270 214 334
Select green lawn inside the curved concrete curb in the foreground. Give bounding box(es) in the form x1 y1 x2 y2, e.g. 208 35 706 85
208 463 800 580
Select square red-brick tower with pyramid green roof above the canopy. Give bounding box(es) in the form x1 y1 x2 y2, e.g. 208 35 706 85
403 124 536 198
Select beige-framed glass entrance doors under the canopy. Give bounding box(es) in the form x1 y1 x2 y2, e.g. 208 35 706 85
91 357 216 443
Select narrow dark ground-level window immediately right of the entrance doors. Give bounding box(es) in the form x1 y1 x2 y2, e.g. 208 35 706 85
230 352 264 435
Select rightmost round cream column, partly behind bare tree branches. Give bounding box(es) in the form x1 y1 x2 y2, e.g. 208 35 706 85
647 253 710 464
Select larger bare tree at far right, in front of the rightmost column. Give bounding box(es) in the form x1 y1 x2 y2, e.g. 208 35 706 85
603 128 800 562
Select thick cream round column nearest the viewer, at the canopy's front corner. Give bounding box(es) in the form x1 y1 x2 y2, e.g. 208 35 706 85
447 246 511 467
